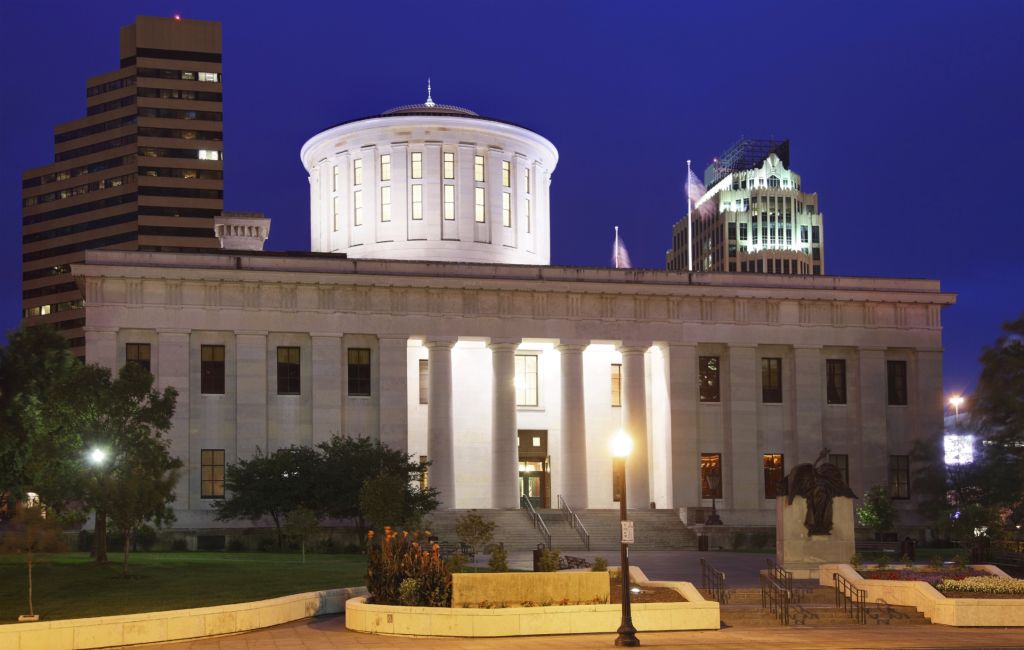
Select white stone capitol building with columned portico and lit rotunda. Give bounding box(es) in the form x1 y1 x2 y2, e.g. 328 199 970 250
74 94 953 528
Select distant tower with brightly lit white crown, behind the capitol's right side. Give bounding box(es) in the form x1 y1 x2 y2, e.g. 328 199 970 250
666 139 824 275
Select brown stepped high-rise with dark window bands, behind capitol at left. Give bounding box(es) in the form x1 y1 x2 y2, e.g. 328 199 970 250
22 16 224 355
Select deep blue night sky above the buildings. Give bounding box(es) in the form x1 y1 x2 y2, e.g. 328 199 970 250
0 0 1024 391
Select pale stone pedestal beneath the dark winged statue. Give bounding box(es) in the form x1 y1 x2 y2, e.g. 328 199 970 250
775 496 854 579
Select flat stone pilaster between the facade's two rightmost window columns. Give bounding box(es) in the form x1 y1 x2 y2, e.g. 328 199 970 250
850 348 889 494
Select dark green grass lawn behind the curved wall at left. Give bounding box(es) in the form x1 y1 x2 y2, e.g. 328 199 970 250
0 553 367 623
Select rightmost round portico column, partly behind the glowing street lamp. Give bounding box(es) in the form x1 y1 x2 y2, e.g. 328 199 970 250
620 345 650 509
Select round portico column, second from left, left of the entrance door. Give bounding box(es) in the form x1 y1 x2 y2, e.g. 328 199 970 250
490 339 519 508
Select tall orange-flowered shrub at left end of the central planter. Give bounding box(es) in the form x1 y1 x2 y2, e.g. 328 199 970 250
367 526 452 607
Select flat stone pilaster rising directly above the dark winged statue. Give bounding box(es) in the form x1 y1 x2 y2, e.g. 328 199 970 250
784 345 825 462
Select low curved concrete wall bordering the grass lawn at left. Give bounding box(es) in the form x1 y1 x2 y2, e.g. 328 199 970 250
0 587 367 650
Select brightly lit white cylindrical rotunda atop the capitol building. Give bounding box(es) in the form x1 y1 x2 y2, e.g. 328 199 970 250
301 91 558 264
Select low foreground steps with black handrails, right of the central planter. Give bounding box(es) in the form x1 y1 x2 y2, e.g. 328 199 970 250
706 580 931 627
